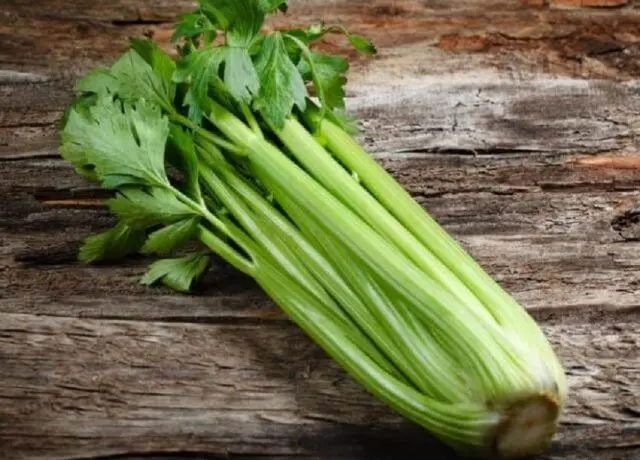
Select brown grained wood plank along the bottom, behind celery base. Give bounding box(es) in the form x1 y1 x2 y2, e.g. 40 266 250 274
0 312 640 460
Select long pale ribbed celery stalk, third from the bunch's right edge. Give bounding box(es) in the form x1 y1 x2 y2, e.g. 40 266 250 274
204 102 537 398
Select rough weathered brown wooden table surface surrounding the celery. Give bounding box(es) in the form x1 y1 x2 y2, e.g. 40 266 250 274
0 0 640 460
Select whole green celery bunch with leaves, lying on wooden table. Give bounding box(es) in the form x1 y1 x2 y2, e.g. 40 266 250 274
61 0 567 458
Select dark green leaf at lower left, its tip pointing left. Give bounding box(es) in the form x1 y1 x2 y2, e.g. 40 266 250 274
78 222 146 263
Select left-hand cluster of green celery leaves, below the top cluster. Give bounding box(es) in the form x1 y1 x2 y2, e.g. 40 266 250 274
61 94 209 291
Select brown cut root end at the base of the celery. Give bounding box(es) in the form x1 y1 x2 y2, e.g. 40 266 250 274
494 393 560 459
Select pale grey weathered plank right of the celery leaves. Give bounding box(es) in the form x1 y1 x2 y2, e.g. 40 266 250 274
350 73 640 153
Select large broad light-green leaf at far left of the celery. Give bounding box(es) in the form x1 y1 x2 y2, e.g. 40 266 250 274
61 97 169 185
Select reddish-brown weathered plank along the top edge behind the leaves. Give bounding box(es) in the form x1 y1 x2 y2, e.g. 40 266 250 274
0 0 640 78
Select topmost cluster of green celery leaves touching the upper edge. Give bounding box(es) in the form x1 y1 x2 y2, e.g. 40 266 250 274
173 0 376 127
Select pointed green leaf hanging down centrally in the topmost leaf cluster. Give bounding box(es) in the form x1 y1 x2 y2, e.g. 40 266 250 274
254 32 307 127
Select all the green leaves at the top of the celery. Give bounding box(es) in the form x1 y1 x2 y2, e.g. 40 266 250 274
60 0 375 291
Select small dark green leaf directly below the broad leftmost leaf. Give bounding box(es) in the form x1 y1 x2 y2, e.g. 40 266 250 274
107 187 197 229
